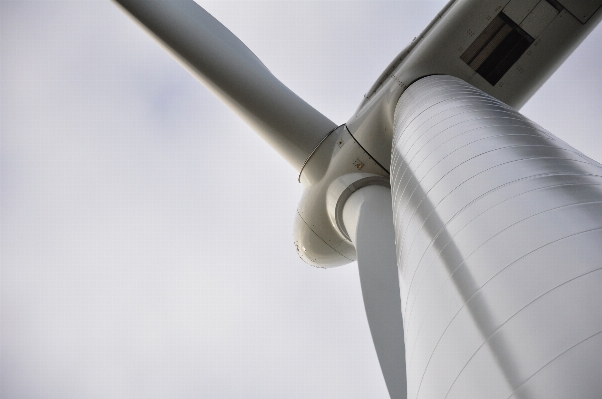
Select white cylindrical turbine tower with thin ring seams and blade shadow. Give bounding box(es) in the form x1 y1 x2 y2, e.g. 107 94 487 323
391 76 602 399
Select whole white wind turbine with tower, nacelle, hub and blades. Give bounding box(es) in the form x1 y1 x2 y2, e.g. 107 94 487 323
113 0 602 397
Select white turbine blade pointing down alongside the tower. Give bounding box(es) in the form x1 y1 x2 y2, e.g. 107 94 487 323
343 186 407 399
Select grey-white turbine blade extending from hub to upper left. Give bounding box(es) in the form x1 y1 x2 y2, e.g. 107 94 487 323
116 0 336 171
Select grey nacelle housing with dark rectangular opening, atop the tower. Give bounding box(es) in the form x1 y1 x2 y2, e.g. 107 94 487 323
347 0 602 169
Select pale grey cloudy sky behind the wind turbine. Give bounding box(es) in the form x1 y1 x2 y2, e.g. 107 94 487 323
0 0 602 399
